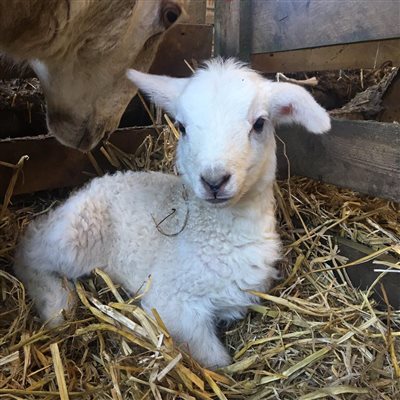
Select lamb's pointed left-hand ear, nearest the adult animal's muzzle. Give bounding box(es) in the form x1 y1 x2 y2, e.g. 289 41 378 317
126 69 189 117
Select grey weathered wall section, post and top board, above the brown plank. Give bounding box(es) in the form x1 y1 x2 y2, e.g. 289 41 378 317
215 0 400 58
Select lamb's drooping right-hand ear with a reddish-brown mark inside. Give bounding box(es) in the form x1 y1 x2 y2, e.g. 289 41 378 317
266 82 331 133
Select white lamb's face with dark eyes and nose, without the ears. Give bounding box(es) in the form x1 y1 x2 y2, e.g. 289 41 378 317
176 69 276 205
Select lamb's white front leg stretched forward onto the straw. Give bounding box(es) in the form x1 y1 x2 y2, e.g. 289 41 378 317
143 300 231 369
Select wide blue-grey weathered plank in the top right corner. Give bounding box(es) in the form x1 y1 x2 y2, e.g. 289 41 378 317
252 0 400 53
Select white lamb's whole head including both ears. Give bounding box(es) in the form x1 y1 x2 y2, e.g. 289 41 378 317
127 59 330 205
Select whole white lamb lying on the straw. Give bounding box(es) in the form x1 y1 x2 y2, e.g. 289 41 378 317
15 59 330 368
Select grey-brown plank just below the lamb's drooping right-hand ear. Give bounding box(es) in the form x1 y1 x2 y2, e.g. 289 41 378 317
277 120 400 202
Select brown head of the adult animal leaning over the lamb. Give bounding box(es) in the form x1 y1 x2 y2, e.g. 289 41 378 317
0 0 186 151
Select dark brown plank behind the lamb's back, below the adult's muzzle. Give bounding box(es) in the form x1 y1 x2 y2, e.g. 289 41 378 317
0 128 153 198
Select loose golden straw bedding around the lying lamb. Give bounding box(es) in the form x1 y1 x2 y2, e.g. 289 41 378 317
0 131 400 400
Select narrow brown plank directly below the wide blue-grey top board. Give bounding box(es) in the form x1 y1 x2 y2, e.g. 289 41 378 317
251 39 400 73
